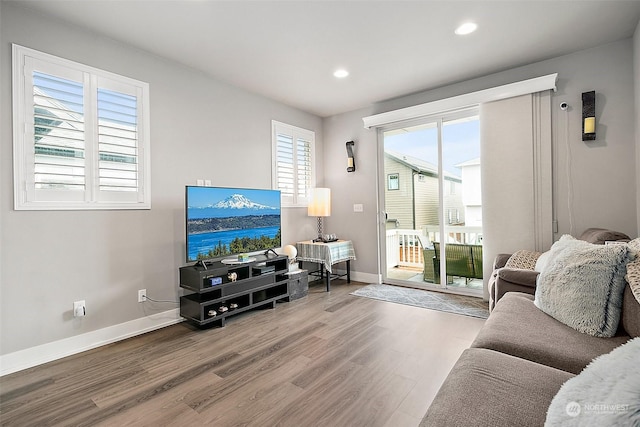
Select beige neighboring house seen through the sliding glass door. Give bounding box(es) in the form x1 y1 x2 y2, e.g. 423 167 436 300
384 151 465 230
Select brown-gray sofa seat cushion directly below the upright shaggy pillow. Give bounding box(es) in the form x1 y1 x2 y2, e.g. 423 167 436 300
471 292 629 374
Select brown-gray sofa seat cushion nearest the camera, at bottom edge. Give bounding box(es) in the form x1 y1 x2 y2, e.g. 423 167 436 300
420 348 573 427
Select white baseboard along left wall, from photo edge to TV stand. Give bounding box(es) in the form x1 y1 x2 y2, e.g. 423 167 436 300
0 308 184 376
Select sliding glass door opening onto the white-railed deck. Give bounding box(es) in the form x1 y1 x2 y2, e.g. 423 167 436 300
379 110 482 295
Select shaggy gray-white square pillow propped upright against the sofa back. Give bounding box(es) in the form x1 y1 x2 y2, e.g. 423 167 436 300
534 235 634 337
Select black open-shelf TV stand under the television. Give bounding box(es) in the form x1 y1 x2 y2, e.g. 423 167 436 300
180 254 289 327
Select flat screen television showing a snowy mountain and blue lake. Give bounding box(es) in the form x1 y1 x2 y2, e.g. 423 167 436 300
185 186 282 262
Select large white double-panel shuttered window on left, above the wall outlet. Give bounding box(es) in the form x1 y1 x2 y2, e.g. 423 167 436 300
13 45 151 210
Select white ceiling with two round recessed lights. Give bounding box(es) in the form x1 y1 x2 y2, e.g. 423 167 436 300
3 0 640 117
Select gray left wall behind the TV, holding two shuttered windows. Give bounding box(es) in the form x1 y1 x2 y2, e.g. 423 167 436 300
0 3 324 354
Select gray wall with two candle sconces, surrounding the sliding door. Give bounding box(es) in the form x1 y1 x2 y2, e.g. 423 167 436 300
324 36 638 284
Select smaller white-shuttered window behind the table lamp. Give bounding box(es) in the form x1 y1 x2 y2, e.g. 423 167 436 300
271 121 316 207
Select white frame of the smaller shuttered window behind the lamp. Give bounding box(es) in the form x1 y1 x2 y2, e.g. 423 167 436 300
271 120 317 208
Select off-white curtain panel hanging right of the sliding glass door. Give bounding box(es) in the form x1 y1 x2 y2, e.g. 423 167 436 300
480 91 553 297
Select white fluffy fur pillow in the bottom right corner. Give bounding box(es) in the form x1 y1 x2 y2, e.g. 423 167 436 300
544 338 640 427
